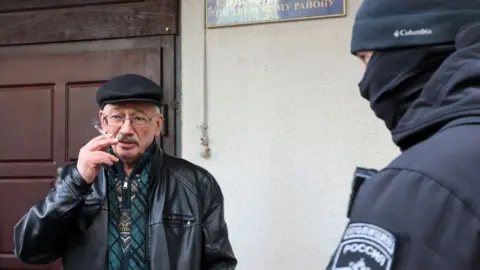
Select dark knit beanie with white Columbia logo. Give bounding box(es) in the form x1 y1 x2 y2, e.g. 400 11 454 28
351 0 480 54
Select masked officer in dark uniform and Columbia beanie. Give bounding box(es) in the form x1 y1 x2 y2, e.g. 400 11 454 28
327 0 480 270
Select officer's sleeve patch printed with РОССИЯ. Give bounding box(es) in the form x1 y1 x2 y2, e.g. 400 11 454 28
331 223 396 270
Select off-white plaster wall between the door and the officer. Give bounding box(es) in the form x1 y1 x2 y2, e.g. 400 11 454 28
181 0 398 270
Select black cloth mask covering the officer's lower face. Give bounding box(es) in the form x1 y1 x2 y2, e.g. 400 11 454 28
359 44 455 130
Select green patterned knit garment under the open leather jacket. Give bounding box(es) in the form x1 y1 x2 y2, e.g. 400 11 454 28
107 144 154 270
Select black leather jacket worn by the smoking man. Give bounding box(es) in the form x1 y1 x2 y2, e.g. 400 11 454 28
14 149 237 270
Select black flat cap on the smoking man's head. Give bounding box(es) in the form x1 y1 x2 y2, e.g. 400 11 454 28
97 74 163 109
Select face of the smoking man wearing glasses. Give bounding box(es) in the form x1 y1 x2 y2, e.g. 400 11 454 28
99 102 163 163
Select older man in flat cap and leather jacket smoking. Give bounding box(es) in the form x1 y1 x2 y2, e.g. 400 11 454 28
14 74 237 270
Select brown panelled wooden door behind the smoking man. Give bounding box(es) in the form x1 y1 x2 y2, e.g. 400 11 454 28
0 37 175 270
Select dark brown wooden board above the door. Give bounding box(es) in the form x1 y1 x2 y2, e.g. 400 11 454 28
0 0 174 45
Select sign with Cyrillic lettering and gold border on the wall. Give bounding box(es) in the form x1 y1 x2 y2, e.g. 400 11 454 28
205 0 346 28
